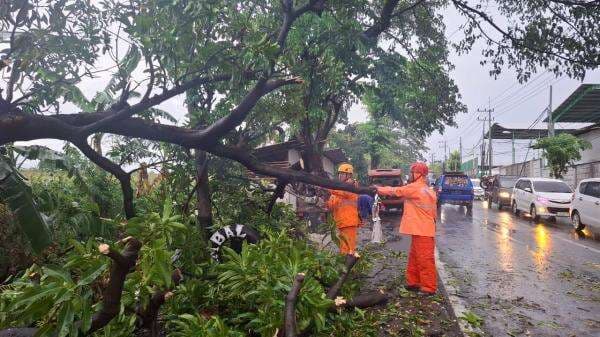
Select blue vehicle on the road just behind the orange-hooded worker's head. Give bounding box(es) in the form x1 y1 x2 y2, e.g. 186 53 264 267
435 172 474 214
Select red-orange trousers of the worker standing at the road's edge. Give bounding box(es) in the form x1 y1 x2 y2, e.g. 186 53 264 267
406 235 437 293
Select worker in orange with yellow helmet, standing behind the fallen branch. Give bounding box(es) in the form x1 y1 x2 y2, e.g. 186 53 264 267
326 164 361 254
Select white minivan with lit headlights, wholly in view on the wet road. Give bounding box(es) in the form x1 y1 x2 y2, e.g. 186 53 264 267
511 178 573 221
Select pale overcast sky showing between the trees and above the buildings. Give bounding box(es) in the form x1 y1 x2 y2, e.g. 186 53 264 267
18 2 600 164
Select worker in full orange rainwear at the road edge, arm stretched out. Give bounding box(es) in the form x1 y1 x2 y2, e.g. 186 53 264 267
377 162 437 295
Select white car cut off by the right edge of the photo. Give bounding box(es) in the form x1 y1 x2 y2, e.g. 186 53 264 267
571 178 600 231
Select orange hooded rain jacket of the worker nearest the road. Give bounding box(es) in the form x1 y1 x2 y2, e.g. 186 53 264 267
377 177 437 237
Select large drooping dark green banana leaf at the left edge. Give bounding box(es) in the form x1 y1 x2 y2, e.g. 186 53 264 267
0 156 52 253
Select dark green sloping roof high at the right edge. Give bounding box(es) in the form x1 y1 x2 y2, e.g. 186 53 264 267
544 84 600 123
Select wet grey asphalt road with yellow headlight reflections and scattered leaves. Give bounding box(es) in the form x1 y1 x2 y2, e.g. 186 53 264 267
436 202 600 337
